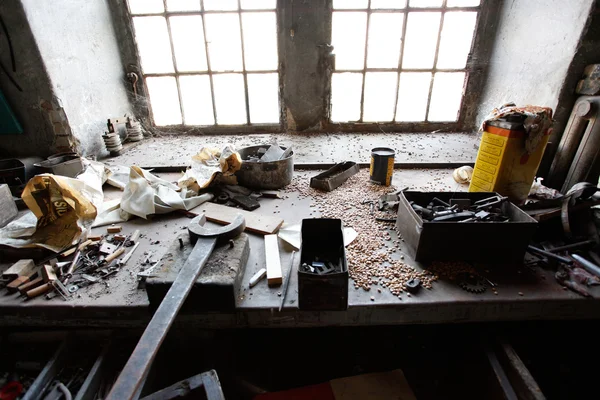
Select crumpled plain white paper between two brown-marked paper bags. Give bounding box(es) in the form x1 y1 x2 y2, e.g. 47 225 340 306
118 166 213 220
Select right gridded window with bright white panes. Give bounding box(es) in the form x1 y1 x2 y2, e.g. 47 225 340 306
330 0 480 123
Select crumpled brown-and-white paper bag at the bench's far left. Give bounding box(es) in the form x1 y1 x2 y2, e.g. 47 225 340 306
0 173 104 252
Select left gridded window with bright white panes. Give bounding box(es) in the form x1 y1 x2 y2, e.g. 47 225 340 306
128 0 280 126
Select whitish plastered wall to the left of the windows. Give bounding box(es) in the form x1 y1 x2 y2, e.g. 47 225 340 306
22 0 131 155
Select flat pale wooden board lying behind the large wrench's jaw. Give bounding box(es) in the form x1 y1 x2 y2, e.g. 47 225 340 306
194 203 283 235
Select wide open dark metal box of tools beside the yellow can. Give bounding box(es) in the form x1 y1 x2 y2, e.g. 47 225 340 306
396 191 537 263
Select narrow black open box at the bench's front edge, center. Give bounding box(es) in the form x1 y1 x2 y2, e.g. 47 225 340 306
298 218 348 310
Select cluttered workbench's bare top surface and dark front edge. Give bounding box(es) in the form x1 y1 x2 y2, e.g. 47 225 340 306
0 170 600 328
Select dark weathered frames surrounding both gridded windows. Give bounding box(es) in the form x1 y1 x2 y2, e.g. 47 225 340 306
109 0 501 135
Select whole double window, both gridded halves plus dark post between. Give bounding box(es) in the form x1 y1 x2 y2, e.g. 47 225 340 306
127 0 491 132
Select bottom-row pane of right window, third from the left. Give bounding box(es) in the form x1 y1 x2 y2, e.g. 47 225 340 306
396 72 431 121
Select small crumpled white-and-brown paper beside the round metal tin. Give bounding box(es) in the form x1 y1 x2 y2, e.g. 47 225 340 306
177 145 242 192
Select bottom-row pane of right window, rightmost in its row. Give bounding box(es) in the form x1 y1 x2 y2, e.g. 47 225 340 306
427 72 465 121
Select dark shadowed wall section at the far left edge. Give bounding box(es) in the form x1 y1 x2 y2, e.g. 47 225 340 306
0 0 55 158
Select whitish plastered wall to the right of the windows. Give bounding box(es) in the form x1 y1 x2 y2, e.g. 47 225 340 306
477 0 594 123
